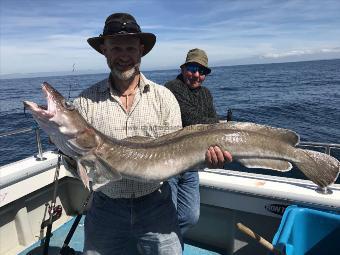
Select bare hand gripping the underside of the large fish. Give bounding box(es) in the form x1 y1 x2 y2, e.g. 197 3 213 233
205 146 233 168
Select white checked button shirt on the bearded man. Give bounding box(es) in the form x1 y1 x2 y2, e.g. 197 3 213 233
74 73 182 198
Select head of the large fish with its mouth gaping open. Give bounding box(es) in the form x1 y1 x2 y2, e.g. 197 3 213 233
24 82 96 156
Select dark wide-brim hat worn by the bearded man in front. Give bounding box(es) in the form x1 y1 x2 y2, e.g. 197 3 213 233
87 13 156 56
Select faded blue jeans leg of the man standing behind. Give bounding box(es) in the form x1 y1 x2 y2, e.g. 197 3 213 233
168 171 200 234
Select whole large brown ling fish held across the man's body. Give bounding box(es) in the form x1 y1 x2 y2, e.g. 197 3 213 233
24 83 339 188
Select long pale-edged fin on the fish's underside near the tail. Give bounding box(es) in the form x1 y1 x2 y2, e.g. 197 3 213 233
237 158 292 172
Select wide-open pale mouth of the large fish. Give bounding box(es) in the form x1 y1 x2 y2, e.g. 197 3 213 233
24 82 57 119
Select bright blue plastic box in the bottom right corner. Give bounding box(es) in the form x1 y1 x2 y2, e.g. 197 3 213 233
273 205 340 255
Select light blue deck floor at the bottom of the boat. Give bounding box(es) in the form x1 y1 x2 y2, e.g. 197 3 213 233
19 217 220 255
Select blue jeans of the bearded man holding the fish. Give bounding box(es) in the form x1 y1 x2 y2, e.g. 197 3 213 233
83 183 182 255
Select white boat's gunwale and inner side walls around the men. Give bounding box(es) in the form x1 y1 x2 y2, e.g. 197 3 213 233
0 152 340 255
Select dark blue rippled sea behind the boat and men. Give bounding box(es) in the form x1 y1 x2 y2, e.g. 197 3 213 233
0 59 340 181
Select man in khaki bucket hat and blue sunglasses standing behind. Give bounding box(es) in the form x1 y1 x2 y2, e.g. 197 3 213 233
165 48 232 234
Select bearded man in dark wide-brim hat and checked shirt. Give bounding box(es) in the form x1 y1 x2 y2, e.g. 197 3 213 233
66 13 230 255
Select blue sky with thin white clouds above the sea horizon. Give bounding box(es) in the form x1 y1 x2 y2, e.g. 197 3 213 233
0 0 340 75
